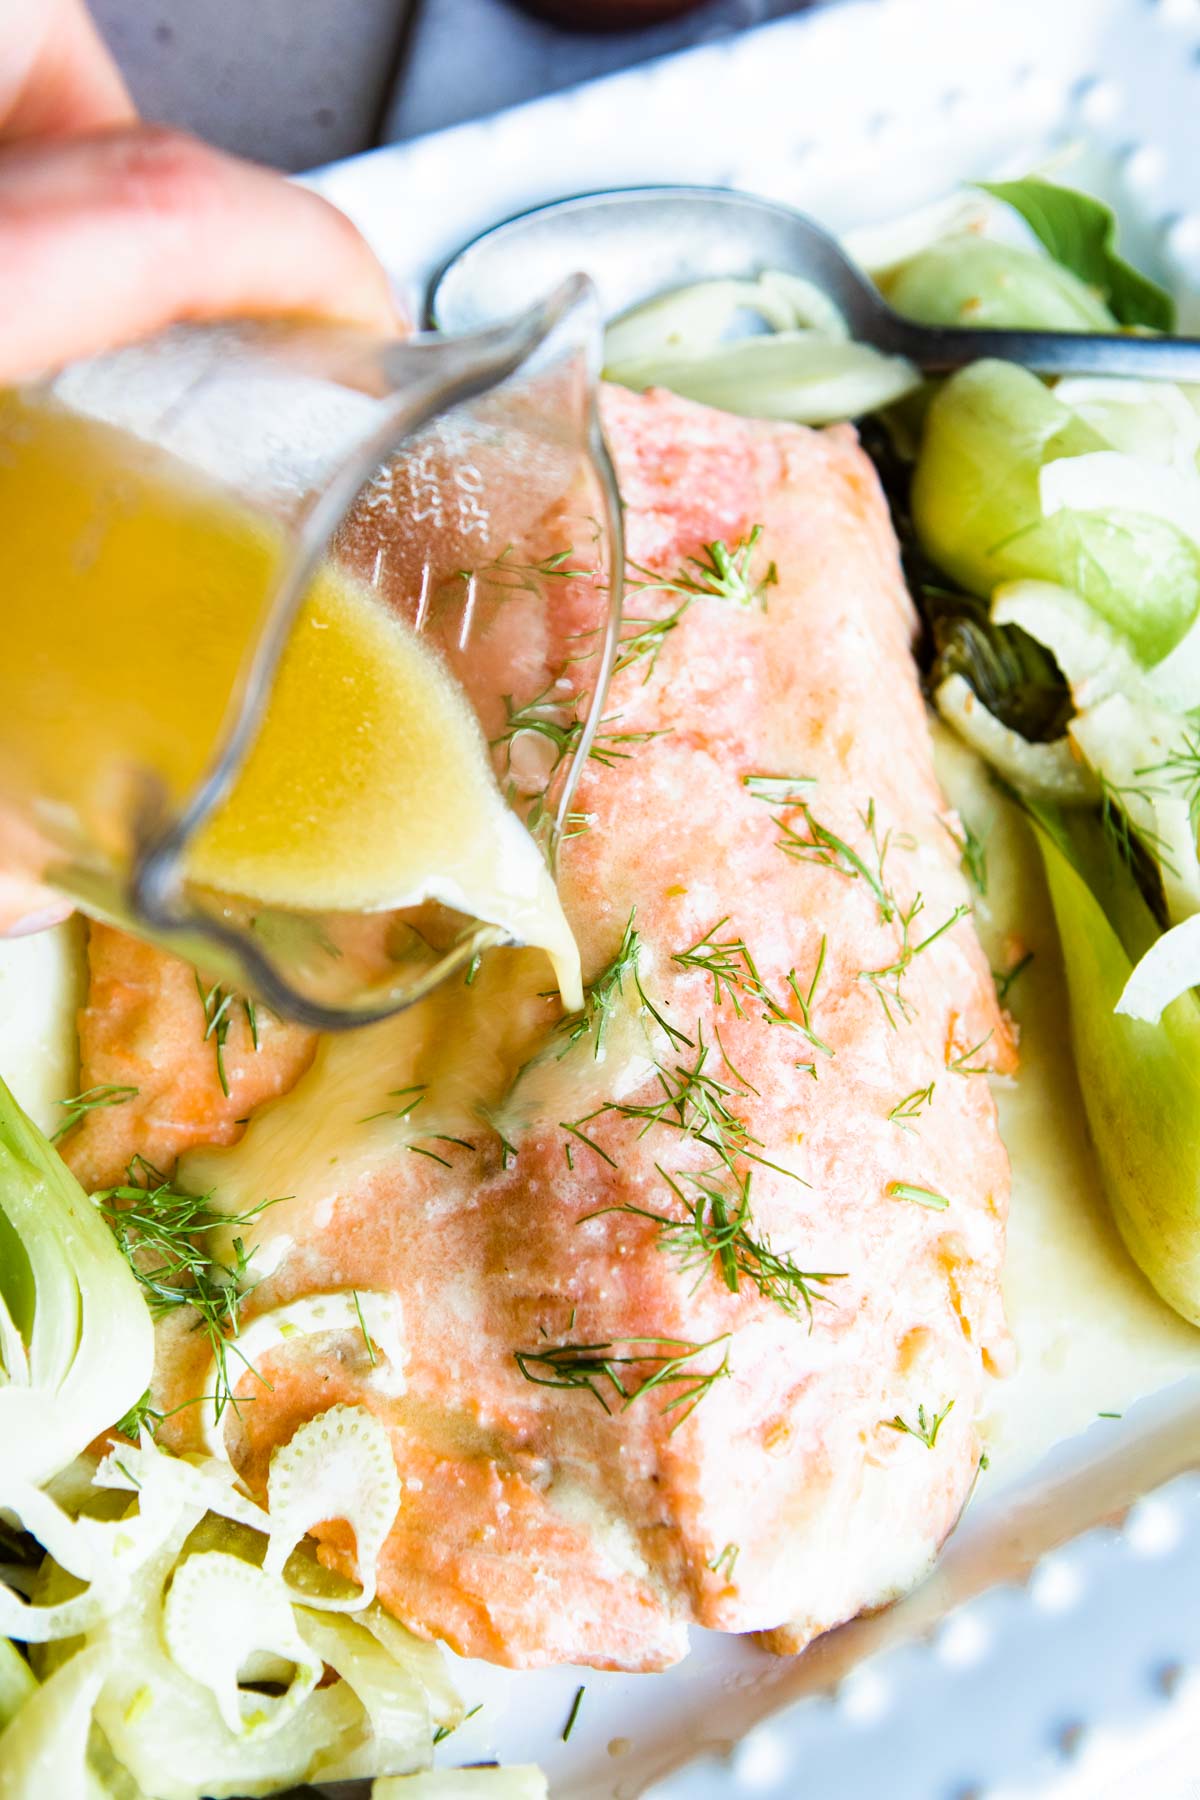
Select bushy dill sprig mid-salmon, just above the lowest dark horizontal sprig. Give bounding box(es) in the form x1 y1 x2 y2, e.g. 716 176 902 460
579 1165 846 1327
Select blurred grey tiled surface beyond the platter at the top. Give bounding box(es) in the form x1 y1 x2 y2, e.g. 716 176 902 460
89 0 802 169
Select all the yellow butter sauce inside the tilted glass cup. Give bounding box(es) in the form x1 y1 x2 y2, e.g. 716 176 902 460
0 394 581 1008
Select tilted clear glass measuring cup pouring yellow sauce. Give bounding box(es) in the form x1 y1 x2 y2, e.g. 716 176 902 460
0 277 621 1028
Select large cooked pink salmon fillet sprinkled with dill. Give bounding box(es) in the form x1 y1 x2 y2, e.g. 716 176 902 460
88 391 1013 1669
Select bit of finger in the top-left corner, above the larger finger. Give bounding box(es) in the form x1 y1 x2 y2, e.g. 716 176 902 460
0 0 135 142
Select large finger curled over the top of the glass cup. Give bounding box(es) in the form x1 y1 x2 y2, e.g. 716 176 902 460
0 126 401 382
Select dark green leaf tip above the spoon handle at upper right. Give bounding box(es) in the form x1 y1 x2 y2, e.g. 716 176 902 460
975 175 1175 331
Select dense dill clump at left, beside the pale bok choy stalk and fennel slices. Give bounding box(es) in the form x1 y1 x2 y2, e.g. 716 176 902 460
95 1157 277 1418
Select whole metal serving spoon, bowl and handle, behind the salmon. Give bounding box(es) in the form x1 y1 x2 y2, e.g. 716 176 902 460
426 187 1200 382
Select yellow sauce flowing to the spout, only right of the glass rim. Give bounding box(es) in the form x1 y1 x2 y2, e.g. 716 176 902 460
187 571 583 1012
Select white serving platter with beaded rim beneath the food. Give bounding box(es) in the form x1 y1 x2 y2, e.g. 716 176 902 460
302 0 1200 1800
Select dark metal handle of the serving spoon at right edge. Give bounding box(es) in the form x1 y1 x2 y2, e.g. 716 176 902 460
880 315 1200 382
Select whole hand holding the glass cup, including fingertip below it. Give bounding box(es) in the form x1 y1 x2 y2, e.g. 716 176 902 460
0 0 405 934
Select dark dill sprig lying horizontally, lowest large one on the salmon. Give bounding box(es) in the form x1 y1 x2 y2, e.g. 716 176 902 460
513 1332 732 1436
